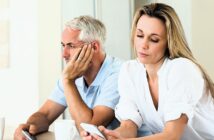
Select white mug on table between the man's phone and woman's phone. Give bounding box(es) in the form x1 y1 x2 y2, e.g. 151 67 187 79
54 120 81 140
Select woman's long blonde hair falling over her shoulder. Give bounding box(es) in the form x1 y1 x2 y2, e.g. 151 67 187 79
131 3 214 99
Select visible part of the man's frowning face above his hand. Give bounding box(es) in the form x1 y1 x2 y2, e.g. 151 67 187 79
61 28 84 63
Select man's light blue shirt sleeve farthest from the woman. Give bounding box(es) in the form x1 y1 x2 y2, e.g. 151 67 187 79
49 80 67 107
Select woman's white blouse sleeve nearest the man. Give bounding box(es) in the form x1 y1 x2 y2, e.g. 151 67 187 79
115 63 143 128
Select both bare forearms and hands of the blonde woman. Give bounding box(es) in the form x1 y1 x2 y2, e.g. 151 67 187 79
82 114 188 140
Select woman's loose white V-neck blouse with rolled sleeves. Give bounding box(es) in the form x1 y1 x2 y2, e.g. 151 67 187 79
115 58 214 140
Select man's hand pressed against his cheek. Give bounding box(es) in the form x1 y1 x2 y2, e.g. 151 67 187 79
63 44 94 81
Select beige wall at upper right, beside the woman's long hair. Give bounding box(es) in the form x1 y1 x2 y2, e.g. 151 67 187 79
192 0 214 80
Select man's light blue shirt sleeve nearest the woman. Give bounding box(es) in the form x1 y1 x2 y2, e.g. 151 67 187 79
94 72 119 110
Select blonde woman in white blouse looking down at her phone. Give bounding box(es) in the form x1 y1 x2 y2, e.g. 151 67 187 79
83 3 214 140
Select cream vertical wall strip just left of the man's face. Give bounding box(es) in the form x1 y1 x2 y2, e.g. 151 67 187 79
37 0 62 106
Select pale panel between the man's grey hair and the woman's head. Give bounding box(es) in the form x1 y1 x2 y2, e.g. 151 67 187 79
97 0 132 60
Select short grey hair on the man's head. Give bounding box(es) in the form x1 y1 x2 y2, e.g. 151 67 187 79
65 16 106 47
